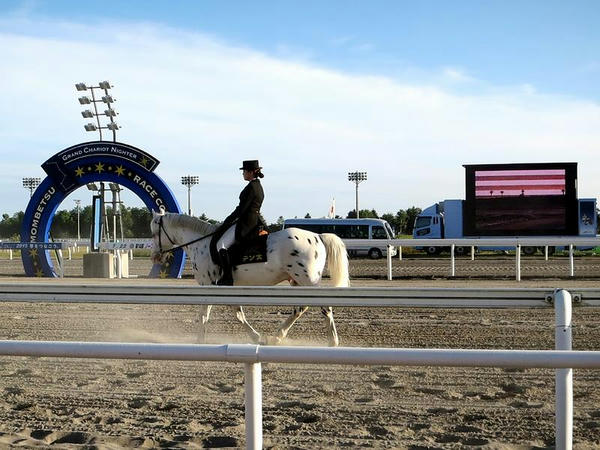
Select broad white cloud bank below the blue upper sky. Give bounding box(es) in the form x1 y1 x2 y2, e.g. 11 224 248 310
0 18 600 221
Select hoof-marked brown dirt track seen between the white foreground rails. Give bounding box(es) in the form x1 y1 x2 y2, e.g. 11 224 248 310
0 258 600 449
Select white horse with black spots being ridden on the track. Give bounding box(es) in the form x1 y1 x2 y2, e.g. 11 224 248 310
150 212 350 346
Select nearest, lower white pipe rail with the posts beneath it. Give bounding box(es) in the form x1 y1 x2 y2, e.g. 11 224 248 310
0 341 600 449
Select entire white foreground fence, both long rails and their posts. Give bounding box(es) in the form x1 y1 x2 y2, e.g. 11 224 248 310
0 283 600 449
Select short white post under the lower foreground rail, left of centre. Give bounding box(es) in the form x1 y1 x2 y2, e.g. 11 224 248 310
244 363 263 450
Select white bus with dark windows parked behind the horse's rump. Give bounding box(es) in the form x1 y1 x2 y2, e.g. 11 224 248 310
283 219 396 259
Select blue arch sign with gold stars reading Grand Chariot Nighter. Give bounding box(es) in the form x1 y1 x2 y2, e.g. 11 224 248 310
21 141 185 278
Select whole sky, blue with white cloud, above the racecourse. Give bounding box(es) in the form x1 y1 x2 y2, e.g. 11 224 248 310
0 0 600 221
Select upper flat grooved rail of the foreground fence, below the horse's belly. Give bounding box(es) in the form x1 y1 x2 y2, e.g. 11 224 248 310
0 281 600 308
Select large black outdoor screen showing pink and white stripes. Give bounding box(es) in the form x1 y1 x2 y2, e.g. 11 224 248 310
463 163 578 236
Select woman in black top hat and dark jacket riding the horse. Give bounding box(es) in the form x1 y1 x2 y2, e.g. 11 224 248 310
215 159 267 286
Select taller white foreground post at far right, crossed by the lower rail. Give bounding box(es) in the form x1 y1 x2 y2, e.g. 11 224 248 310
554 289 573 450
